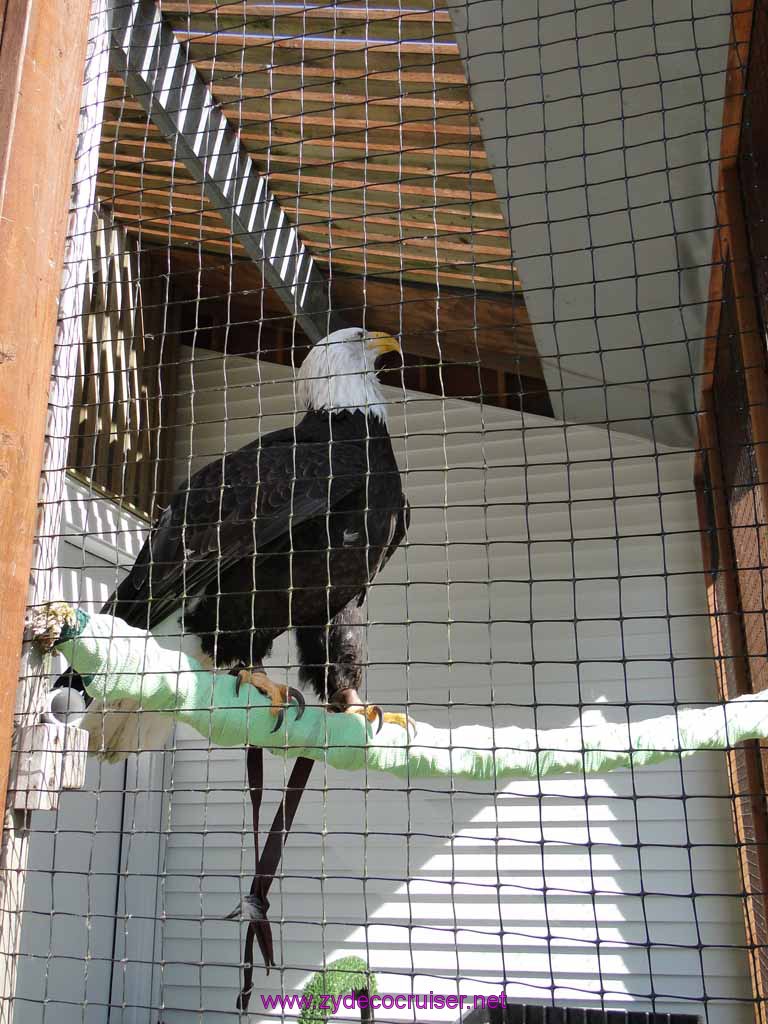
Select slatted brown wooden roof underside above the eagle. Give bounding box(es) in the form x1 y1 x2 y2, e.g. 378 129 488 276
98 0 541 362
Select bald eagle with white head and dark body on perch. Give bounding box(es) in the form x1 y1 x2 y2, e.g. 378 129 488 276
61 328 410 757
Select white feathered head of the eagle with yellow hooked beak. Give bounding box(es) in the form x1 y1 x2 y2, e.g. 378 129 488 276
297 327 401 423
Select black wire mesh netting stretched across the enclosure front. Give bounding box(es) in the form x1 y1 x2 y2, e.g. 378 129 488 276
6 0 768 1024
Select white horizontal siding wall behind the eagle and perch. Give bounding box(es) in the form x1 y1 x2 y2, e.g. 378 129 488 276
148 350 752 1024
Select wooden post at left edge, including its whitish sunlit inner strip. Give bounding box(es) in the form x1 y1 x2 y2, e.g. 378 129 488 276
0 0 102 1024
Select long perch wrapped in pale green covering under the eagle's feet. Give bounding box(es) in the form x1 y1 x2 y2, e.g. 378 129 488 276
31 605 768 782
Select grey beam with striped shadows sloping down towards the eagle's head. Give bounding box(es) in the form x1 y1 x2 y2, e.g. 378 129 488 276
112 0 343 342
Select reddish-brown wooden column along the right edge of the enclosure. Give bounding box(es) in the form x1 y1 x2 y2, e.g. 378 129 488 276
696 6 768 1024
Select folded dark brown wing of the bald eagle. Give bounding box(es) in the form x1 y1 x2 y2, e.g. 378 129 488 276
104 441 367 629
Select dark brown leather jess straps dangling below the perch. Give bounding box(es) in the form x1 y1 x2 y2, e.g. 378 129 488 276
238 746 314 1011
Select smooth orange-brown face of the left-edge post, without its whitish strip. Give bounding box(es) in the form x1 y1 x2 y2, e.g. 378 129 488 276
0 0 90 1007
